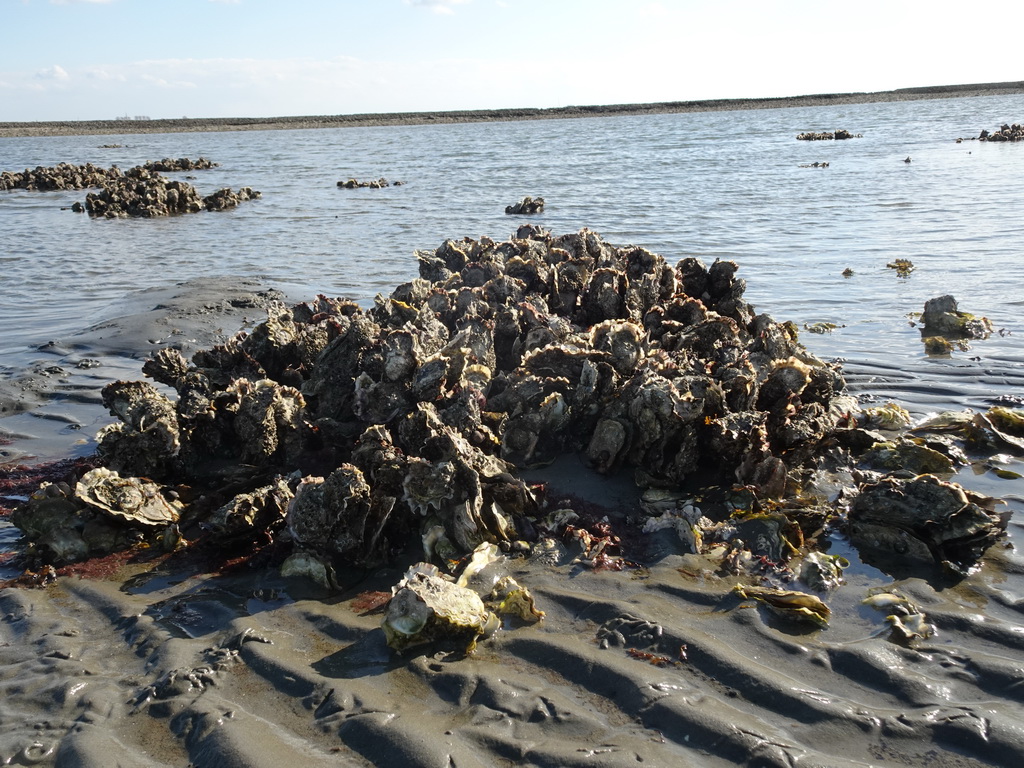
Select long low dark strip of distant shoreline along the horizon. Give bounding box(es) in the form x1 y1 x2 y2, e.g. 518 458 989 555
0 81 1024 137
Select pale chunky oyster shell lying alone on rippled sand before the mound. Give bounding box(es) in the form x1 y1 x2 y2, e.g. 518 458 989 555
382 563 498 653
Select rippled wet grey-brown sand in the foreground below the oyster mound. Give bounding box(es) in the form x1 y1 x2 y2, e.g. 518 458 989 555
6 475 1024 768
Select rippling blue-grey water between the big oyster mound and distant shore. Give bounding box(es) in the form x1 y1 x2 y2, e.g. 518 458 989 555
0 95 1024 454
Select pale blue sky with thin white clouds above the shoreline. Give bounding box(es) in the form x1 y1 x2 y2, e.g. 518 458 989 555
0 0 1024 122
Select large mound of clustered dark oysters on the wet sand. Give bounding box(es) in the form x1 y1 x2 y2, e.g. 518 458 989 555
12 225 1020 593
